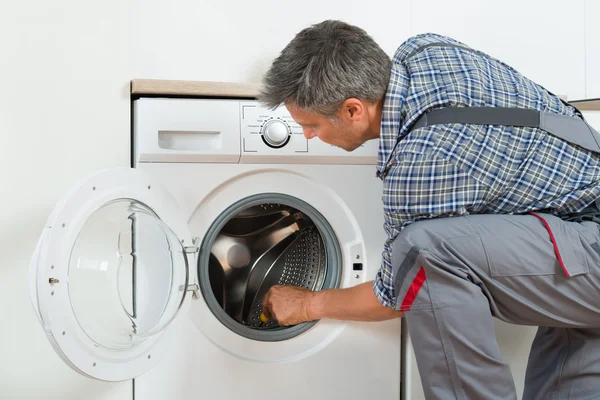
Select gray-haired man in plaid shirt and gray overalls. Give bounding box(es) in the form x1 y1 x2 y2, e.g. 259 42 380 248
260 21 600 400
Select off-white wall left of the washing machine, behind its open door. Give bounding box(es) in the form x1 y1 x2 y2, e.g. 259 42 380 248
0 0 132 400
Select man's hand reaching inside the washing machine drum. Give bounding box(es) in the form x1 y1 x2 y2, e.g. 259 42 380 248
263 285 314 326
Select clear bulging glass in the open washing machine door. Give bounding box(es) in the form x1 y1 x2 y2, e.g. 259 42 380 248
69 199 188 350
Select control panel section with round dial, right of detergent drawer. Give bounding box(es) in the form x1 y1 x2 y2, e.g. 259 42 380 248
240 101 377 164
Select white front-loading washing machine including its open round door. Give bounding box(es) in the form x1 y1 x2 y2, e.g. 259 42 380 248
30 90 402 400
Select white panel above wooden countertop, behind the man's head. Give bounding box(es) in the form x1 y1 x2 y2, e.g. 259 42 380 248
133 0 410 82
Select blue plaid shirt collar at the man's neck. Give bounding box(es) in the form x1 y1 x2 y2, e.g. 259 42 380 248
377 63 408 178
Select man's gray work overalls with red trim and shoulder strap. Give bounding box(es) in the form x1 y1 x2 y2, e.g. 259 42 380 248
392 43 600 400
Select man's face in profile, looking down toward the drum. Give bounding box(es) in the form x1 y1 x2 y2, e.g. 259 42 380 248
286 104 367 151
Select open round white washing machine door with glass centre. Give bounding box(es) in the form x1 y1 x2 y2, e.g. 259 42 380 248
30 168 195 381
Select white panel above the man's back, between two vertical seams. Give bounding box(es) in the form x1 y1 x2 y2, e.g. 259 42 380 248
412 0 585 99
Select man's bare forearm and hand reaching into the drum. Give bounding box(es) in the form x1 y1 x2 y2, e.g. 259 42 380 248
263 281 404 326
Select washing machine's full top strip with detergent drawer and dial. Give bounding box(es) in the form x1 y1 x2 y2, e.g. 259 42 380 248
134 98 378 164
